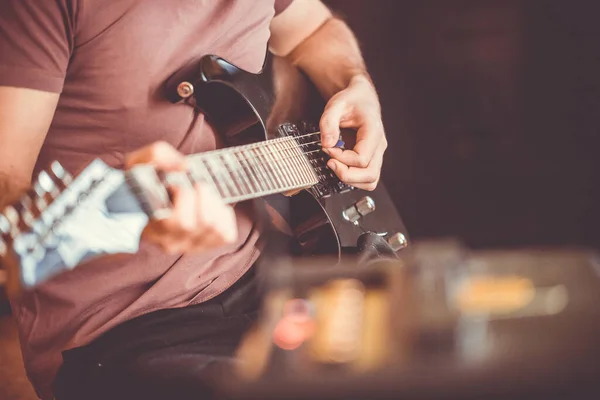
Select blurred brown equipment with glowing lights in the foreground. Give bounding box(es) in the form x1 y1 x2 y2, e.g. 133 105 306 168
219 242 600 400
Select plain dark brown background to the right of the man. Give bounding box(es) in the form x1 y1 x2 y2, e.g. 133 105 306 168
326 0 600 247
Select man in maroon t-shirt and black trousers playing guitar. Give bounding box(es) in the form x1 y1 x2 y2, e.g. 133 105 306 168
0 0 387 400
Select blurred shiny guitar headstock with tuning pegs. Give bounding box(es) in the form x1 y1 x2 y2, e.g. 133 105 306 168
0 160 148 294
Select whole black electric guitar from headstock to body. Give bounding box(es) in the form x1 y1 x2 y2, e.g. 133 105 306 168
0 56 407 292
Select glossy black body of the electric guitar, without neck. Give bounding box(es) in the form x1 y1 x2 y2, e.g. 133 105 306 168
166 54 408 255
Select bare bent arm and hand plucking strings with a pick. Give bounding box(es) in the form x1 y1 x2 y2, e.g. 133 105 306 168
271 0 387 190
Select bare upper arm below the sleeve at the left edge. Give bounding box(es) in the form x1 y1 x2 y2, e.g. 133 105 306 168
0 86 59 209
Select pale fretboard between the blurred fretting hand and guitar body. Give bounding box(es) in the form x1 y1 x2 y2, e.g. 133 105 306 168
189 137 319 203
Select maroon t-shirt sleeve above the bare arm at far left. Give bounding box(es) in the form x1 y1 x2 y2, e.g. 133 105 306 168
0 0 76 93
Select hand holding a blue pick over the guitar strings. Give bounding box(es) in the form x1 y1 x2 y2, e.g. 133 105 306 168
320 76 387 194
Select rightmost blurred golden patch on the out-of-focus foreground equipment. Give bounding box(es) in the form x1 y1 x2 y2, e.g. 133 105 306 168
454 276 536 315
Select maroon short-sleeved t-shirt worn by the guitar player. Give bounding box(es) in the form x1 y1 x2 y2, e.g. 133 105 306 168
0 0 291 398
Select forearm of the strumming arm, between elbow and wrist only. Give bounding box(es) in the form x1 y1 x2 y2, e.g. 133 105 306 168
287 17 371 98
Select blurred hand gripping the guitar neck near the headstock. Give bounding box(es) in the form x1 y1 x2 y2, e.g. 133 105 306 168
126 142 237 254
